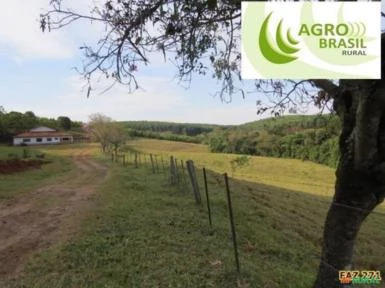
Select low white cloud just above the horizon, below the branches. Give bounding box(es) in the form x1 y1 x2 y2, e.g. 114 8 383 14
29 77 184 121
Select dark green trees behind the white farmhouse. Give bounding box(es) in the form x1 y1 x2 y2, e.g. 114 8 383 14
0 106 82 143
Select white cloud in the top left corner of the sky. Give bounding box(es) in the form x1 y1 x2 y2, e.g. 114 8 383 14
0 0 106 63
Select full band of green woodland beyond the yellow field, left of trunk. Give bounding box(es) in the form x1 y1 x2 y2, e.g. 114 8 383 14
123 115 341 167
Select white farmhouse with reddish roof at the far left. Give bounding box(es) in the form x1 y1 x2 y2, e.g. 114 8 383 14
13 126 73 146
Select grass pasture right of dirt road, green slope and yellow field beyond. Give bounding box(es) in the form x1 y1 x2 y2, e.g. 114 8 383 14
0 140 385 288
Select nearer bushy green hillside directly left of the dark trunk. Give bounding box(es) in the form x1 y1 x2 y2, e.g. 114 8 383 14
207 114 340 167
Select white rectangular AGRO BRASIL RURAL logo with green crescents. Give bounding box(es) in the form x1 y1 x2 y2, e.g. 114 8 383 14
242 2 381 79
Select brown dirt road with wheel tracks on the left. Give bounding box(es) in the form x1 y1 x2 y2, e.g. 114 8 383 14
0 153 107 280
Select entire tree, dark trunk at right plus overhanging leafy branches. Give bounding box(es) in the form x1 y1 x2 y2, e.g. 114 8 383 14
41 0 385 288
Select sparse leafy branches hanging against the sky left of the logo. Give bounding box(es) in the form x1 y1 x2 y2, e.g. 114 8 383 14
41 0 241 95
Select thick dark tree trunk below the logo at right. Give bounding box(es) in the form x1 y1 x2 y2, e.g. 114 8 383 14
314 80 385 288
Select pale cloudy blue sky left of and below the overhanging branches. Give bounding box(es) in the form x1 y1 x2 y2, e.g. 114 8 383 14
0 0 380 124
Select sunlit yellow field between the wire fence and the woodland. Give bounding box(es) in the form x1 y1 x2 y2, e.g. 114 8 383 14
124 139 335 197
